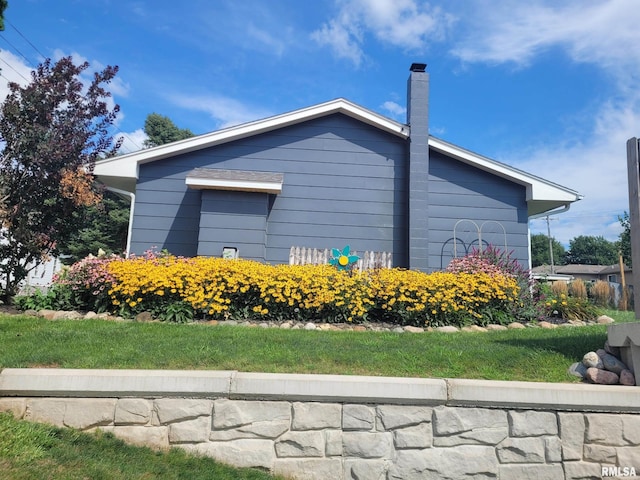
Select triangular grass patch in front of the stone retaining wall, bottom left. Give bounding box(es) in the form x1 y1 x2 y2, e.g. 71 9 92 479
0 413 280 480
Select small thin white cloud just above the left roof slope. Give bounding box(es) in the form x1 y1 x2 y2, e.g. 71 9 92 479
171 95 272 128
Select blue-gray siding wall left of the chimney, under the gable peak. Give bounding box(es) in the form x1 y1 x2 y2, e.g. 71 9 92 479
131 114 408 265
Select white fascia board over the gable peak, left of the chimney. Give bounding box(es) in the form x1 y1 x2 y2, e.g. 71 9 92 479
94 98 409 188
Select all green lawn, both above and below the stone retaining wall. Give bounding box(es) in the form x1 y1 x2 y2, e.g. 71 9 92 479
0 311 635 480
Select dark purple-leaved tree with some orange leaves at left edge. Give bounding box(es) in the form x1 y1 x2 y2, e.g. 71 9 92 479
0 57 120 300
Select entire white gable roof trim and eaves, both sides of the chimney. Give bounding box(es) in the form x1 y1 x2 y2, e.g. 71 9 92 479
93 98 582 217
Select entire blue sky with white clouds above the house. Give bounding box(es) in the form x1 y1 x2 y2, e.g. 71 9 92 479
0 0 640 251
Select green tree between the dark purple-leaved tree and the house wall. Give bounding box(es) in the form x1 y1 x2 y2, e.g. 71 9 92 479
59 190 130 265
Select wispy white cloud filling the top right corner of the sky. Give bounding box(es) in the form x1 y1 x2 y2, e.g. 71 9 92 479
452 0 640 80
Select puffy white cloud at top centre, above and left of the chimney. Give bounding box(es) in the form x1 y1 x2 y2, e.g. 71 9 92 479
311 0 454 66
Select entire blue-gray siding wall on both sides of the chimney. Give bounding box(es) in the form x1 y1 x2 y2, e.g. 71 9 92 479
131 114 528 271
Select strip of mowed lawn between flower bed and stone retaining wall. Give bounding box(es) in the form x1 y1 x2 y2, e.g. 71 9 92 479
0 312 634 382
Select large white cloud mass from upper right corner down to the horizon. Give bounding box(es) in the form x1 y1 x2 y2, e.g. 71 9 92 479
452 0 640 244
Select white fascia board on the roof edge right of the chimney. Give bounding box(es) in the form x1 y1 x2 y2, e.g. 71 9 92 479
429 137 582 203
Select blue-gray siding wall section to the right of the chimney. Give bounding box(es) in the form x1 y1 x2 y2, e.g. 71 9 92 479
429 151 529 271
